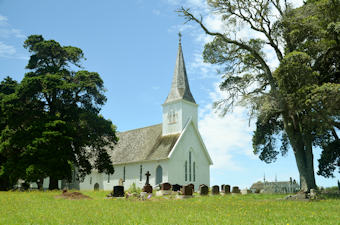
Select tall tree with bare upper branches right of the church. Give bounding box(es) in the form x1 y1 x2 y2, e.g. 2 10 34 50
179 0 340 191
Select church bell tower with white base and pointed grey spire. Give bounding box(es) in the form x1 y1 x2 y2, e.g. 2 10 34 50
162 33 198 136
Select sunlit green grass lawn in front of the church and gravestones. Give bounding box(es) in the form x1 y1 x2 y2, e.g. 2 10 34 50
0 191 340 225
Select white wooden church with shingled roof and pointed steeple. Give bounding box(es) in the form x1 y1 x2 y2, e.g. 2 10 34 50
72 38 212 190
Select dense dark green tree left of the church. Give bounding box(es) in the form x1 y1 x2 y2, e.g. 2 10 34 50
0 35 118 189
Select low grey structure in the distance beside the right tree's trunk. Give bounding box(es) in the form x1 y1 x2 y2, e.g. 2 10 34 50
250 178 300 194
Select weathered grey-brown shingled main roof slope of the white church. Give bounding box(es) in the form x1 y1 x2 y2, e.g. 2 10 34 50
109 124 180 164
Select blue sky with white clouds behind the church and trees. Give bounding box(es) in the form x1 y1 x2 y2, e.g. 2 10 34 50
0 0 340 188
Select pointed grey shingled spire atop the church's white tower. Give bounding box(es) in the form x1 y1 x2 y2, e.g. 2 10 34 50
164 33 196 104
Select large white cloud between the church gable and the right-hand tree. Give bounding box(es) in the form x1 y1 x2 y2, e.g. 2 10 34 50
199 84 256 171
